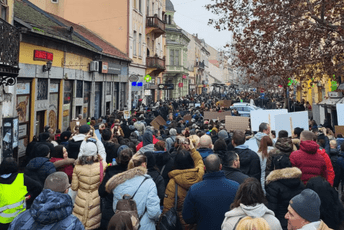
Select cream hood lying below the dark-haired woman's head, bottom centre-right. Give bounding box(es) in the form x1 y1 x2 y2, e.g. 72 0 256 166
225 204 275 218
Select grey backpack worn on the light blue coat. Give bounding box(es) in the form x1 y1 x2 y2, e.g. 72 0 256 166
115 177 148 230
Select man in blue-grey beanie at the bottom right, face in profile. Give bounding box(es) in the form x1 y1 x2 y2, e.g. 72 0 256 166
285 189 330 230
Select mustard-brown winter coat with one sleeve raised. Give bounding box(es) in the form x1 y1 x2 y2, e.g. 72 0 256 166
163 149 204 229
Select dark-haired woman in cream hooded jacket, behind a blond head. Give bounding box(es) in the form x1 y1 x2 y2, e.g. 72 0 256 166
221 178 282 230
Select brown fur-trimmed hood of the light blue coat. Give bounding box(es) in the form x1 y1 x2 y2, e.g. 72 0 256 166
105 166 147 193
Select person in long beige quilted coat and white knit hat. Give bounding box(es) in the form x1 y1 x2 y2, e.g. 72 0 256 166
72 141 106 229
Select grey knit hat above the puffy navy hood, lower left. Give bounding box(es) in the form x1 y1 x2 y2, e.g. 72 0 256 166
44 172 69 193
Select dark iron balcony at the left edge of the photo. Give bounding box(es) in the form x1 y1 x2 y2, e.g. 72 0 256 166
0 18 20 85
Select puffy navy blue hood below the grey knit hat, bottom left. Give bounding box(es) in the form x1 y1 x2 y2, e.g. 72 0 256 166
30 189 73 225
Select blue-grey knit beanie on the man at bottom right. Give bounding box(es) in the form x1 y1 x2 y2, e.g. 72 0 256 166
289 188 321 222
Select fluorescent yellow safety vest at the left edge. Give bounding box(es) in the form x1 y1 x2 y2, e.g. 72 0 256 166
0 173 27 224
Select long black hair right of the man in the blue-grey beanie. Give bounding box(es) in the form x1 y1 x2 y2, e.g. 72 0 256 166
306 176 344 229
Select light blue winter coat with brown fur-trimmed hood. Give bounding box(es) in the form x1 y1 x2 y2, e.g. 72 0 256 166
105 166 161 230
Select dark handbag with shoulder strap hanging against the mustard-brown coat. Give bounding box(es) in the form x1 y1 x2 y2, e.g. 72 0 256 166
158 183 182 230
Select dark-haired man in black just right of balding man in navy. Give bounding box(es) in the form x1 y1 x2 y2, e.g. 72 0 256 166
222 151 249 184
